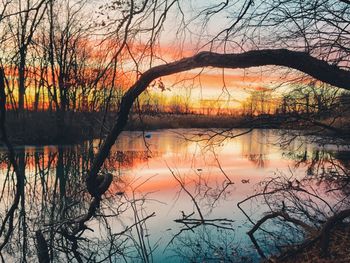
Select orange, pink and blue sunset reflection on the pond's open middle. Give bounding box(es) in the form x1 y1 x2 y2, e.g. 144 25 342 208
96 130 320 262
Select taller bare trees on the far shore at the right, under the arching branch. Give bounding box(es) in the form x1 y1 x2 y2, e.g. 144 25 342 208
241 84 350 118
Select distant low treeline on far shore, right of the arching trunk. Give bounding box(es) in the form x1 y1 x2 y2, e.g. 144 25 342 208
139 84 350 118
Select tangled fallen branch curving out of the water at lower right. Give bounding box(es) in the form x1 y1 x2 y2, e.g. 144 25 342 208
238 178 350 260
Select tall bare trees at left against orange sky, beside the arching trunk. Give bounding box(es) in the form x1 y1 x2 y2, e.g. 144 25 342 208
0 0 129 126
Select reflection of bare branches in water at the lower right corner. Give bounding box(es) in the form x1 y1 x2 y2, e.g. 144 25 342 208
238 149 350 259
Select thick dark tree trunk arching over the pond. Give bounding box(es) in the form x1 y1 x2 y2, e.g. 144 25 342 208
87 49 350 196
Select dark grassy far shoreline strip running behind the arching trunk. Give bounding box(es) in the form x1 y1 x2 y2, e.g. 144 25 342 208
6 112 348 146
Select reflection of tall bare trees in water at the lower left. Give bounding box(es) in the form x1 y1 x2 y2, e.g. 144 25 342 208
0 145 159 262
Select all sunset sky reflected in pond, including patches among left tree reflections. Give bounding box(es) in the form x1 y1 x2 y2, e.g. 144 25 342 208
0 130 346 262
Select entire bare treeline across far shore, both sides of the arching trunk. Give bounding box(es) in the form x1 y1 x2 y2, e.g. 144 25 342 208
0 0 349 143
